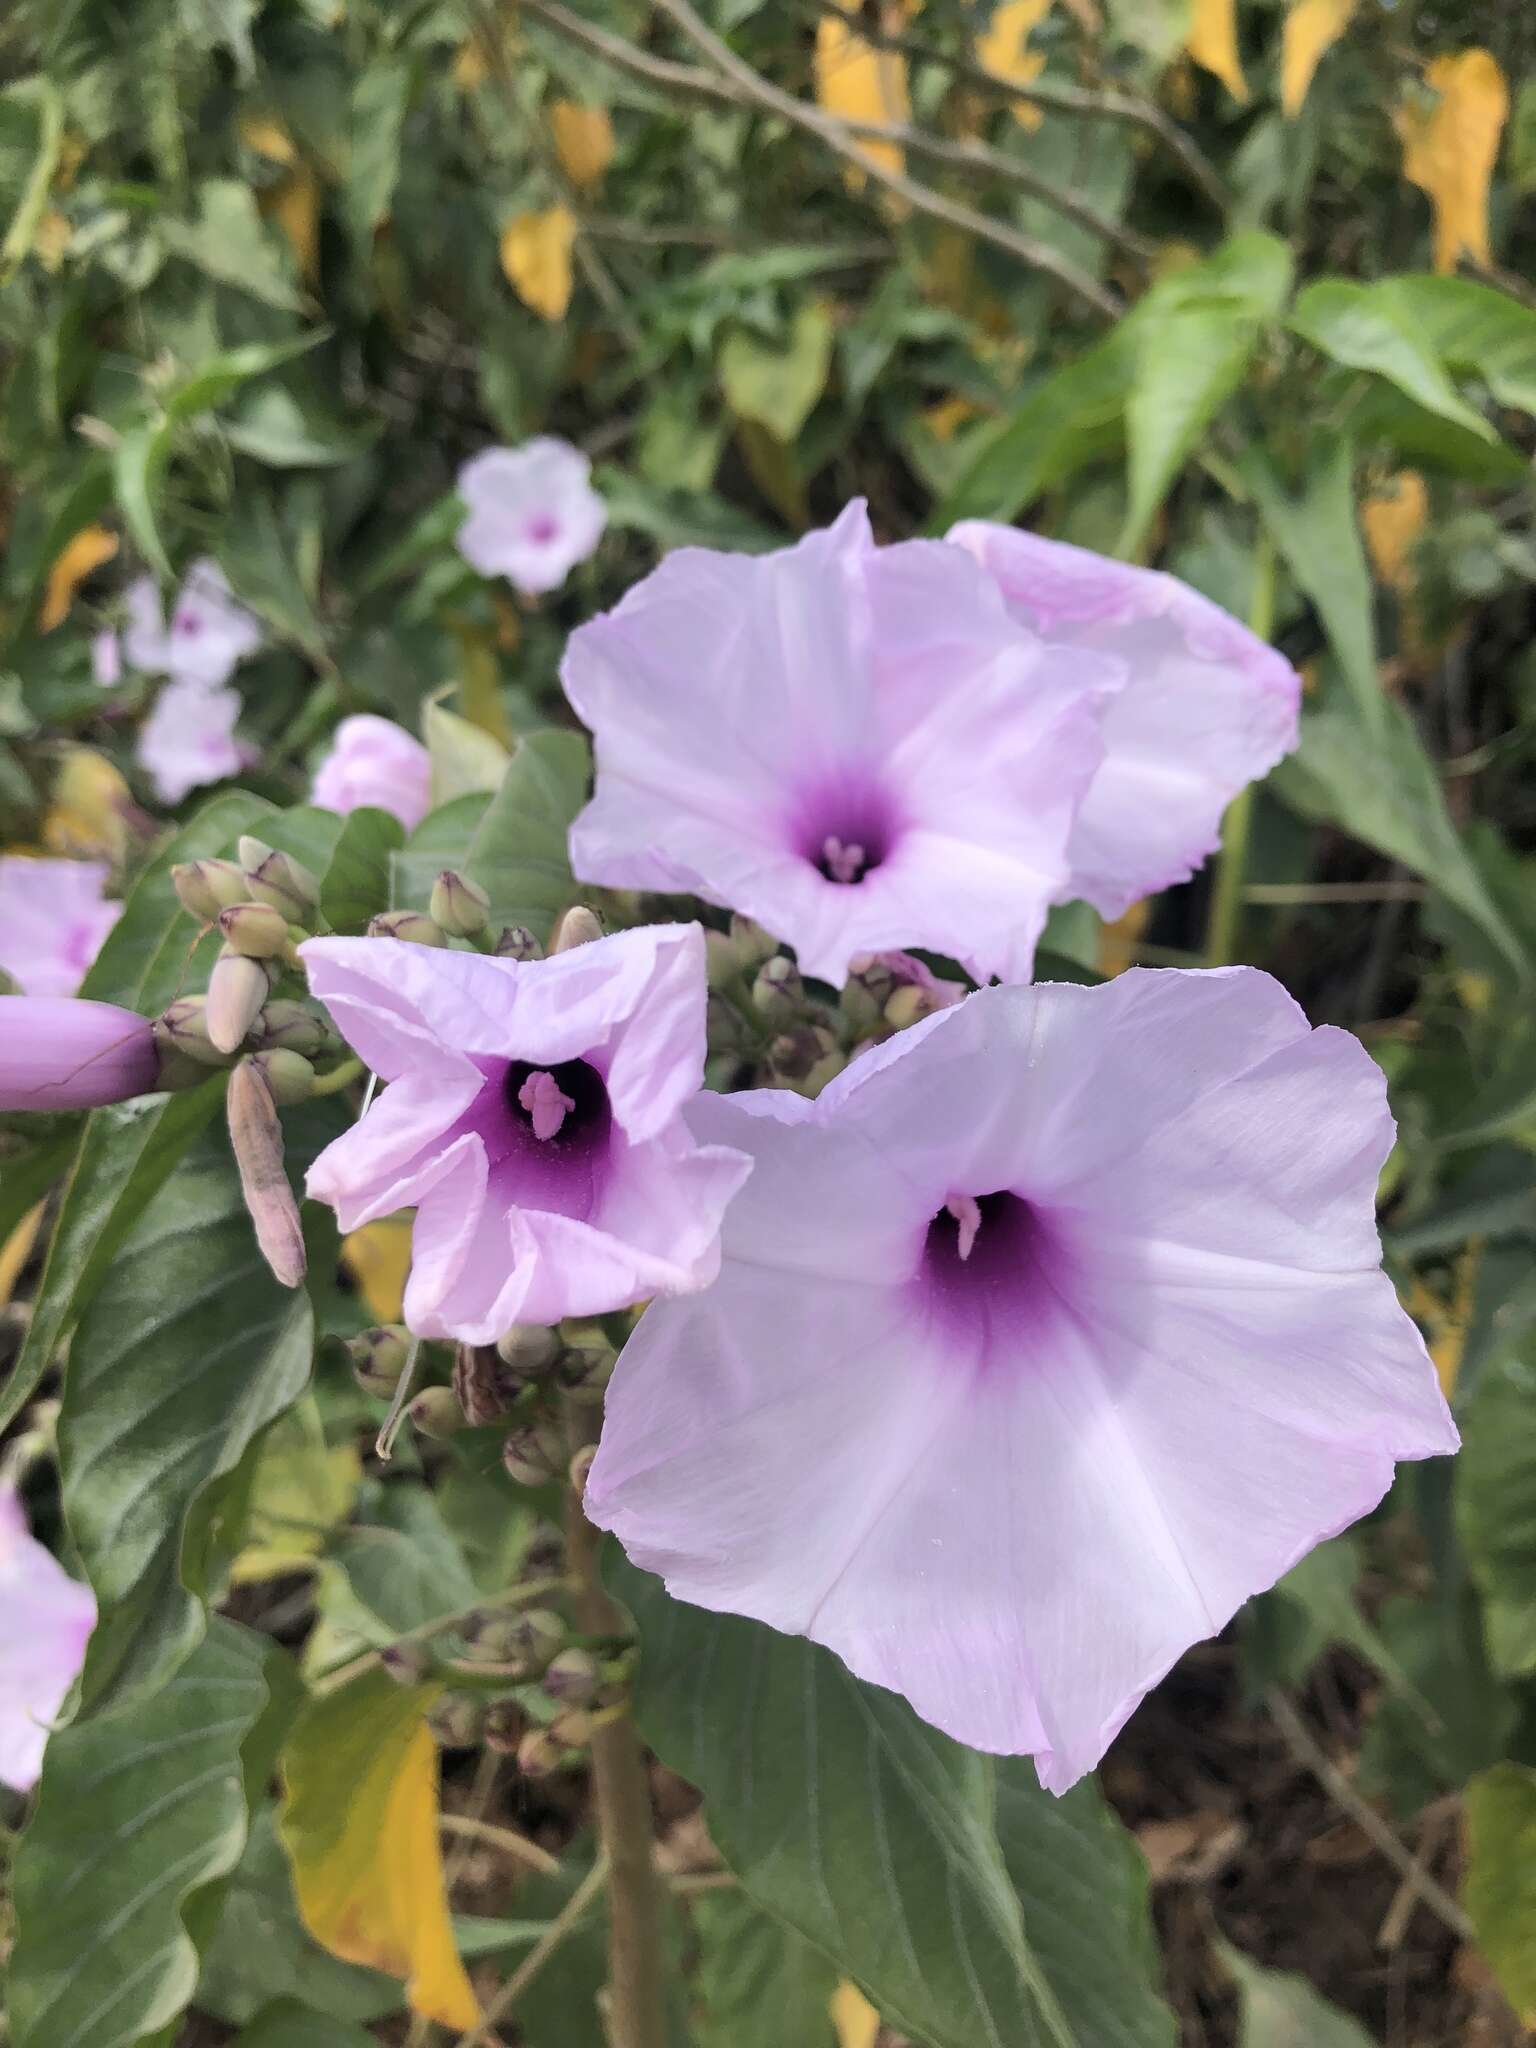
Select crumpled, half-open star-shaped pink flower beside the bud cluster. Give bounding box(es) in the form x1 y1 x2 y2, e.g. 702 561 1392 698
299 924 750 1343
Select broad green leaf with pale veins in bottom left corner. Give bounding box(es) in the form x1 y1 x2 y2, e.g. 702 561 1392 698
8 1620 268 2048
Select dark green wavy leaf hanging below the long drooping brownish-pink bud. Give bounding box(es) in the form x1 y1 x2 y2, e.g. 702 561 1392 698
59 1133 313 1712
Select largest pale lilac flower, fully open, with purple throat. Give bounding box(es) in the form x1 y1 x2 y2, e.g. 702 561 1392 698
586 969 1456 1792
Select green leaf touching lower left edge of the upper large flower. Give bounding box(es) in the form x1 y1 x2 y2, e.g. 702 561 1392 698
465 727 592 940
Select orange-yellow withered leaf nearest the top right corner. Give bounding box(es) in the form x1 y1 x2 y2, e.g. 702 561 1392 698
1397 49 1509 270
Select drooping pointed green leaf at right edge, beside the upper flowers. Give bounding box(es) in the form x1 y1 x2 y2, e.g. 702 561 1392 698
1274 696 1530 979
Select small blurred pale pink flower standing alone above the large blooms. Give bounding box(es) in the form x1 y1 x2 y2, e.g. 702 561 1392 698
459 434 608 594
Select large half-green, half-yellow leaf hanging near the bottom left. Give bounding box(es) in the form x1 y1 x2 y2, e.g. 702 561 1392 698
279 1669 479 2028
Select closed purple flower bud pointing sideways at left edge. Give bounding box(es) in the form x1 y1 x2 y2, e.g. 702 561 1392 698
0 995 160 1110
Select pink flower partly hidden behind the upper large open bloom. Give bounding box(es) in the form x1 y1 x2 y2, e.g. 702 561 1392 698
950 520 1300 918
